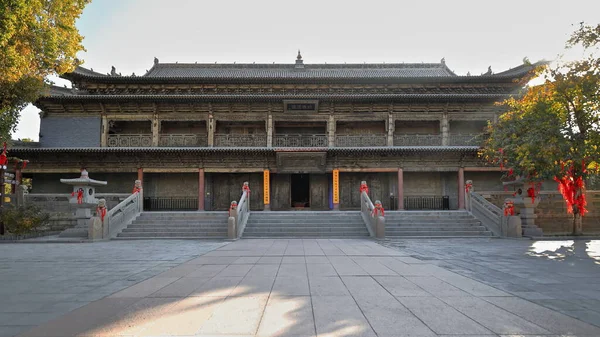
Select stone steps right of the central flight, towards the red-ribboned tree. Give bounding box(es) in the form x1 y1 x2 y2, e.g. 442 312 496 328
385 211 492 239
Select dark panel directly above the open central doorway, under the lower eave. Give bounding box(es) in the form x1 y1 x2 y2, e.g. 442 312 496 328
276 152 327 173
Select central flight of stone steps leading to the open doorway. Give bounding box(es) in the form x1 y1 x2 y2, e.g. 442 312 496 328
242 211 369 238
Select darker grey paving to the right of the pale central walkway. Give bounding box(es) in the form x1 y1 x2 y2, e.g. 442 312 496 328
384 239 600 325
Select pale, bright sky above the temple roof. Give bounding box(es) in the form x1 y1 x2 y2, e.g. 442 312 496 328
13 0 600 140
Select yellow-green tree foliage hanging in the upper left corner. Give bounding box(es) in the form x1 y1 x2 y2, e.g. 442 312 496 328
0 0 91 141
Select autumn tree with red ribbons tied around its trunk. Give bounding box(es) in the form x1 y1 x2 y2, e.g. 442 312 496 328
481 23 600 235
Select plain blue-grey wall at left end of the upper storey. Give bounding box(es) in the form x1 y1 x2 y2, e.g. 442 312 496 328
40 116 101 147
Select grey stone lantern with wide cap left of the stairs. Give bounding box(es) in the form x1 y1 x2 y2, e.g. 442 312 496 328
60 169 107 238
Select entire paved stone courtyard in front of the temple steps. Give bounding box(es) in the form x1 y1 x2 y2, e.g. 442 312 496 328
0 239 600 337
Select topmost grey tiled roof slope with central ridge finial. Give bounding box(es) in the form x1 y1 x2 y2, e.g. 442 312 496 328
144 63 456 79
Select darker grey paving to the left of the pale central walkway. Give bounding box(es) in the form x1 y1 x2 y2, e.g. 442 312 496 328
0 241 225 337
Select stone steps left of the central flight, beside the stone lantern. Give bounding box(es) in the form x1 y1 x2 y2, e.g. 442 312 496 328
116 212 228 240
